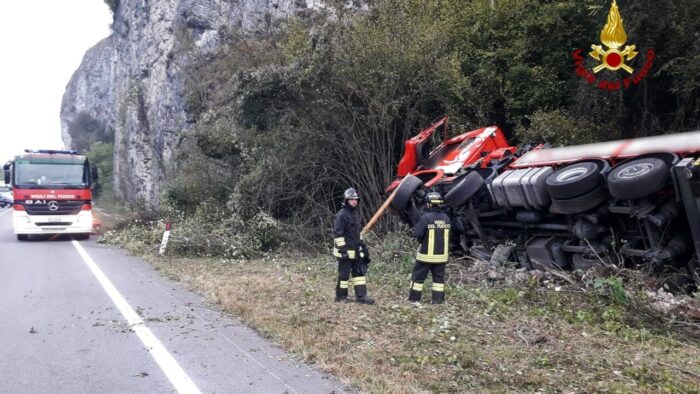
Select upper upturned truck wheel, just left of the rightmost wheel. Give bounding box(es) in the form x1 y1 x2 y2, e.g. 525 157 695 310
546 161 603 199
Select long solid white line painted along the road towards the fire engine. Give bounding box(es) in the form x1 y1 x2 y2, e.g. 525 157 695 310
73 240 201 394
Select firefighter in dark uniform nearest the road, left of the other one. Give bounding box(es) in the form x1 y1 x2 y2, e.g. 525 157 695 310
333 188 374 304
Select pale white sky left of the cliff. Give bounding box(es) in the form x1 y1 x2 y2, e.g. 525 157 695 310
0 0 112 165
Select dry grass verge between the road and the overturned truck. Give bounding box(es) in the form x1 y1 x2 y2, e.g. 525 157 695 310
142 256 700 393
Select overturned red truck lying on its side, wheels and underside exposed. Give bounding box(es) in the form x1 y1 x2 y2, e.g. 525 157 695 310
386 117 700 286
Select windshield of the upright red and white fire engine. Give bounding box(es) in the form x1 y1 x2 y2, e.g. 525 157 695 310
14 162 90 188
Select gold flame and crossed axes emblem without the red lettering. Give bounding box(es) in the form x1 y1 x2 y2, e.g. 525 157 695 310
588 0 638 74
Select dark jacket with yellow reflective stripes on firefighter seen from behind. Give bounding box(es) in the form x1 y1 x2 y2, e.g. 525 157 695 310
413 211 452 264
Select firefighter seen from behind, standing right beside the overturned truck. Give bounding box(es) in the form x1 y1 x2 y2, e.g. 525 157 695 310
408 192 451 304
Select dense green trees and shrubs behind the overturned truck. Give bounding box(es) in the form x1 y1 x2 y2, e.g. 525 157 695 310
167 0 700 244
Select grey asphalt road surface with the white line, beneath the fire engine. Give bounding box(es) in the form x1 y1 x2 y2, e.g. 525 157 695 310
0 208 346 393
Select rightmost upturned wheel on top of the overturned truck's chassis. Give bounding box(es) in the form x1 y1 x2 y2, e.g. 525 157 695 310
608 157 669 200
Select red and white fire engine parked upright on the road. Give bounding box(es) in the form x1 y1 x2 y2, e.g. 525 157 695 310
3 149 97 241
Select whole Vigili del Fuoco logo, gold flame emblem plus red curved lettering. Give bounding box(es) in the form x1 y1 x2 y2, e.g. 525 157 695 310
573 0 655 91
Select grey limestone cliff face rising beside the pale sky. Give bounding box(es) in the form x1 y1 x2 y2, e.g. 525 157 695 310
61 0 357 207
